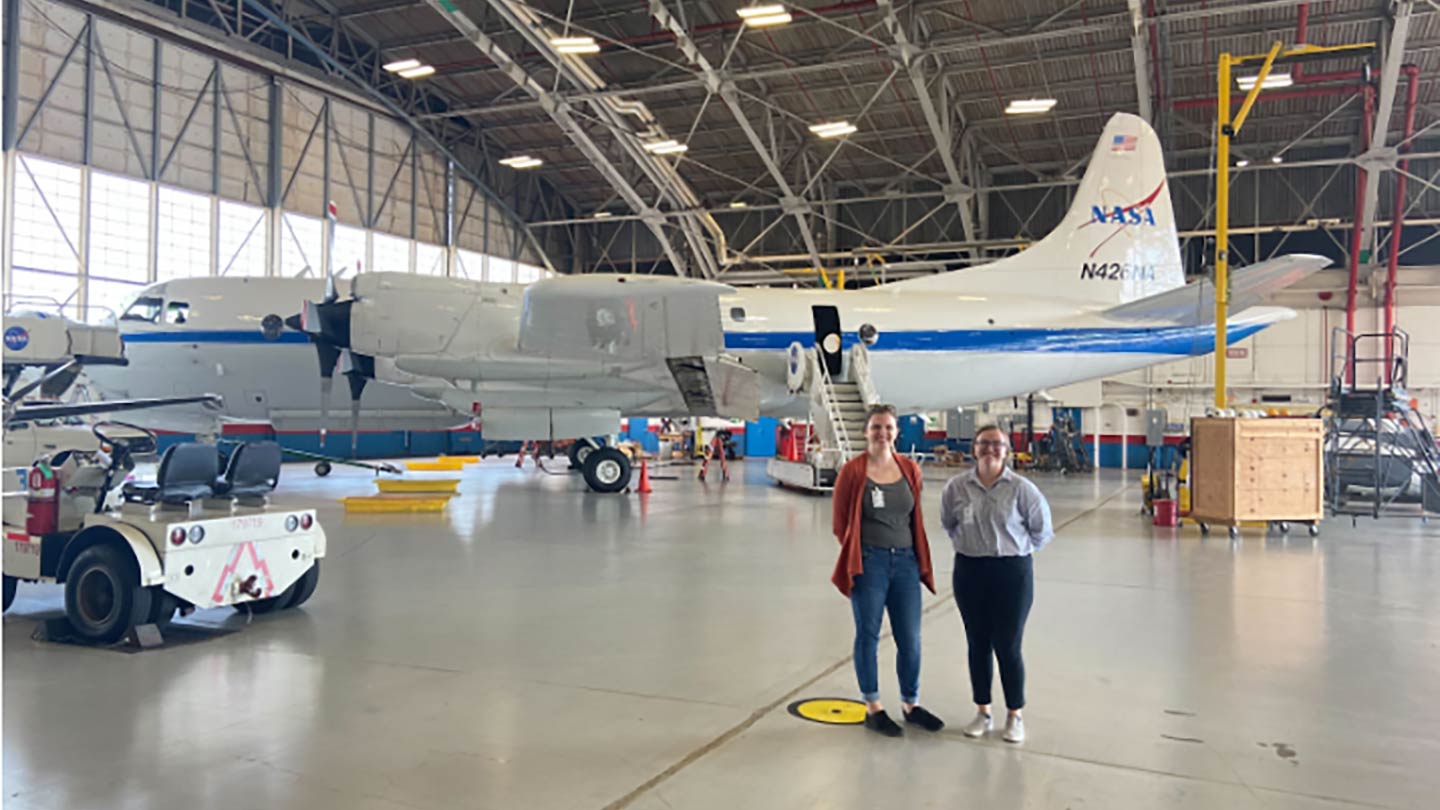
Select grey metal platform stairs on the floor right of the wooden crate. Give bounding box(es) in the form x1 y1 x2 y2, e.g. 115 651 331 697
1325 329 1440 517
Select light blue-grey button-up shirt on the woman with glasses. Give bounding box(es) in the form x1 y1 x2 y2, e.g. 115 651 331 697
940 468 1056 556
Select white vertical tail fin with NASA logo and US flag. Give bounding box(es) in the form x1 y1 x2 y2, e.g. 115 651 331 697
888 112 1185 307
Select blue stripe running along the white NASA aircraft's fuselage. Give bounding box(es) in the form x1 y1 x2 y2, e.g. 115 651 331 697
124 324 1269 356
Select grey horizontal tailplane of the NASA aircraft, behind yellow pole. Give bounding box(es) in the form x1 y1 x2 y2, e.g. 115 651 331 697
1102 254 1331 324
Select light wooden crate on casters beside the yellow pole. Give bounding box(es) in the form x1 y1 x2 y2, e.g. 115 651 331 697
1189 418 1325 526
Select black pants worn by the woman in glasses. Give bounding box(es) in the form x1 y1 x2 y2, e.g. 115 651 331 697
953 553 1035 711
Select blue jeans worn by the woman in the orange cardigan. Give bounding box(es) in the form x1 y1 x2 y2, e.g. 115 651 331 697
850 546 920 703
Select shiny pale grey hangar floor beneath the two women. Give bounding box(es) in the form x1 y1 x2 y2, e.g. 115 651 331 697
3 460 1440 810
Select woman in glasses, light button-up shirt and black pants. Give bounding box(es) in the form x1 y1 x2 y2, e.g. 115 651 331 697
940 425 1056 742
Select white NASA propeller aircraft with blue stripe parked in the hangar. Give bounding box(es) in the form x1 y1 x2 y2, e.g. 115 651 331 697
87 114 1329 490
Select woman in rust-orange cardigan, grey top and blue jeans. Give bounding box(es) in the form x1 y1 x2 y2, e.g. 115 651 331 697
831 405 945 736
